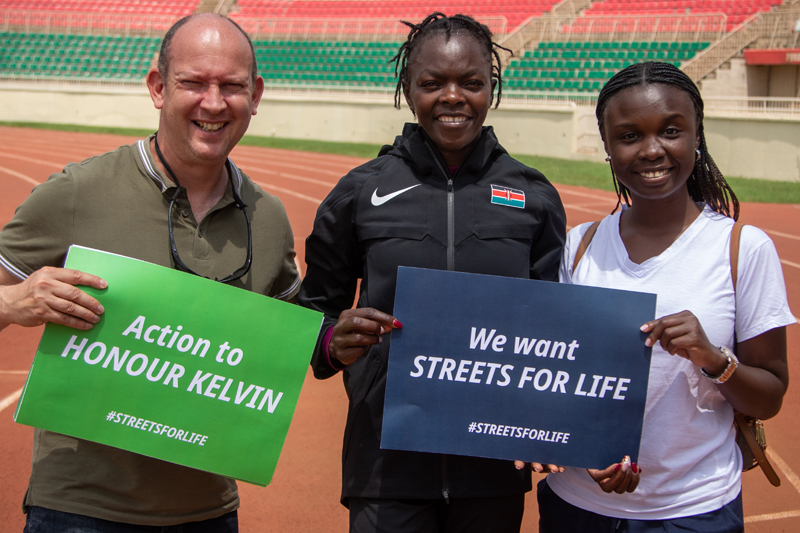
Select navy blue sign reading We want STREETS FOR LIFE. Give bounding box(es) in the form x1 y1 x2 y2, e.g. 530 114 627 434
381 267 656 468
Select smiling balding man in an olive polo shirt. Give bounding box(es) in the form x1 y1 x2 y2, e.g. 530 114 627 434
0 14 300 533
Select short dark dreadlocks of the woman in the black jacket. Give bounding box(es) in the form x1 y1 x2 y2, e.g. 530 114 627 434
388 11 513 109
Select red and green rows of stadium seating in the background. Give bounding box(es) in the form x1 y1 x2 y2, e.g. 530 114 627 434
0 0 792 93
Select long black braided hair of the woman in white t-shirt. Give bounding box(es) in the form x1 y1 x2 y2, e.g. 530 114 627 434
595 61 739 220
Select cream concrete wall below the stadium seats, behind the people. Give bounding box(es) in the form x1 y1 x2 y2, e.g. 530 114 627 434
0 84 800 181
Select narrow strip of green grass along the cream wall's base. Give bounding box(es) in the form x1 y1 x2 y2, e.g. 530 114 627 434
6 122 800 204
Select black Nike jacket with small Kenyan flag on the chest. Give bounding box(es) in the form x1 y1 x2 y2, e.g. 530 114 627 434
299 124 566 505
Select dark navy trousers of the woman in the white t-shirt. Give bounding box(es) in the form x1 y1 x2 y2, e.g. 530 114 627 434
536 474 744 533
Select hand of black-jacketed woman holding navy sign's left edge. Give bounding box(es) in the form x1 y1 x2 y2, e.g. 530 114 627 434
328 307 403 365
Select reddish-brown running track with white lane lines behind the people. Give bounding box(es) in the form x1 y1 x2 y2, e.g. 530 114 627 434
0 127 800 533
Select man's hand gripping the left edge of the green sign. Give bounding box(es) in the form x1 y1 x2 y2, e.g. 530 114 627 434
0 267 108 330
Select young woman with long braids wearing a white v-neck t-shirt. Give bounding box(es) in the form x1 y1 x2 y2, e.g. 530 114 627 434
538 62 795 533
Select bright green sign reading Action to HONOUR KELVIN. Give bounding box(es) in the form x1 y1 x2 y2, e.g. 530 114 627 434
14 246 322 485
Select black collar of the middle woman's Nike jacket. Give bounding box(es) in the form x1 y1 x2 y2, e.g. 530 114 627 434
379 123 506 183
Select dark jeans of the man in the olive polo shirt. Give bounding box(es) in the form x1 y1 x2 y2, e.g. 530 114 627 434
24 506 239 533
